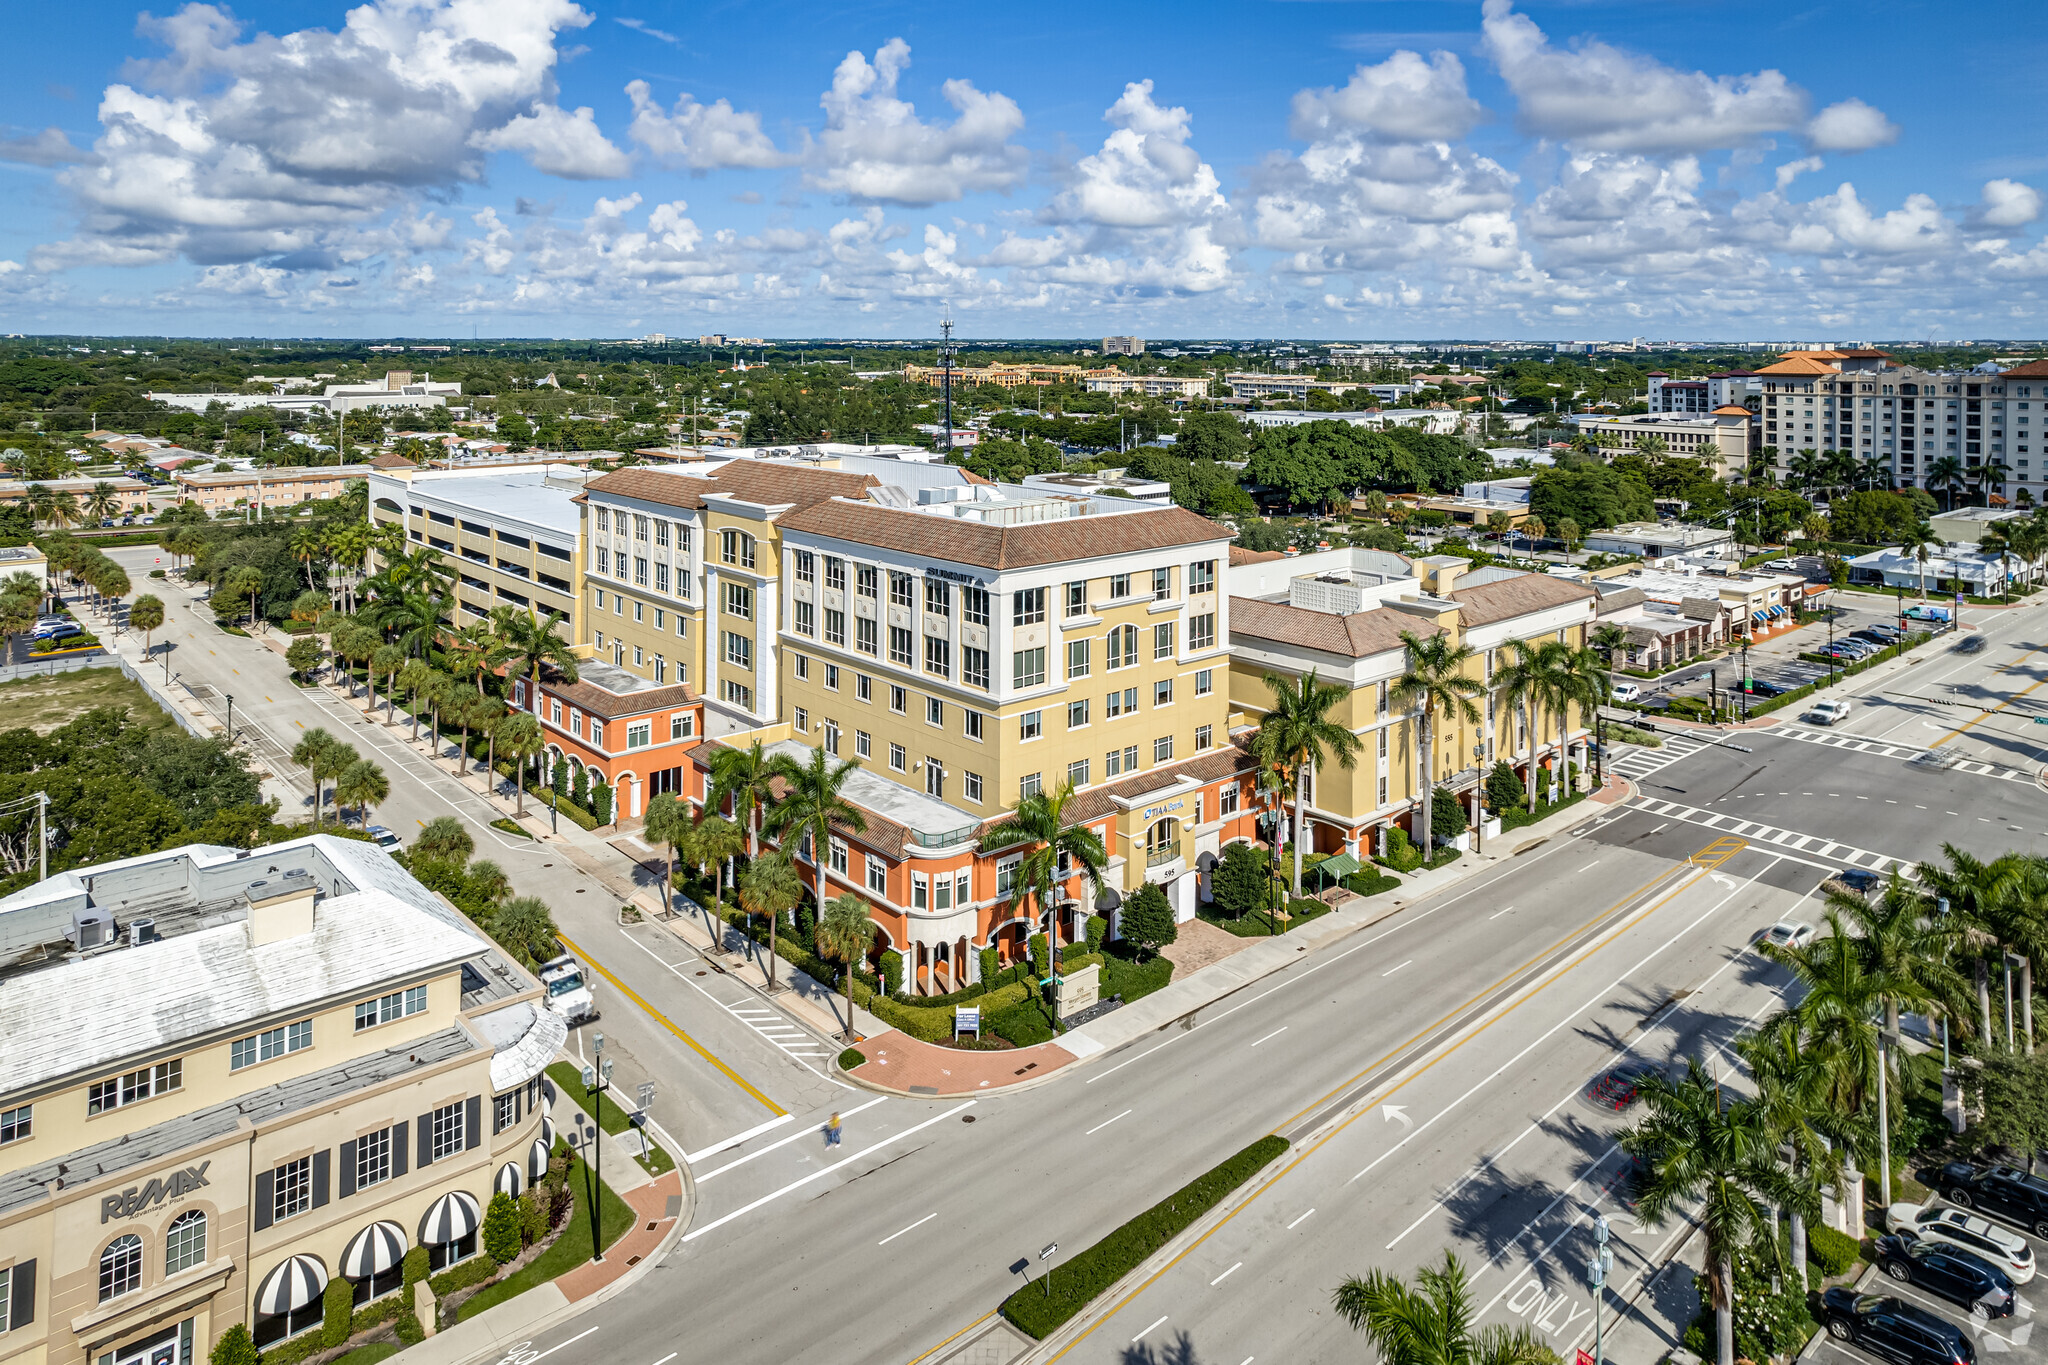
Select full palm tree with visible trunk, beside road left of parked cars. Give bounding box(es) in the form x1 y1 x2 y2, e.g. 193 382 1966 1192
1622 1060 1802 1365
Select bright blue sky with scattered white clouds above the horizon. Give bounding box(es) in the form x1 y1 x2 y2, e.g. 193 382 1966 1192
0 0 2048 340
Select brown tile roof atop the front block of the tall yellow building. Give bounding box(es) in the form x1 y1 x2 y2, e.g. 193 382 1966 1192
782 499 1231 569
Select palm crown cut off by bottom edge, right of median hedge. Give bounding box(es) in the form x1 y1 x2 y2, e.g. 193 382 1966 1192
1331 1250 1556 1365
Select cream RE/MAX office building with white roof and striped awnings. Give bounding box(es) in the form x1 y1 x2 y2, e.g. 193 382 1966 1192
0 835 567 1365
